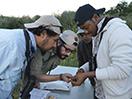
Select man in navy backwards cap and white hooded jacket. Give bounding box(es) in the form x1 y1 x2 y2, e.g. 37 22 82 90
72 4 132 99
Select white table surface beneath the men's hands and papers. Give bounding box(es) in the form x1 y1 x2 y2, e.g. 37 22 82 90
47 66 93 99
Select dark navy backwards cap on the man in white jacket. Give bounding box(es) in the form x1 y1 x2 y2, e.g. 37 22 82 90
74 4 105 26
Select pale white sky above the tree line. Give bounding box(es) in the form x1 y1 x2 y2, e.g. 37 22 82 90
0 0 132 17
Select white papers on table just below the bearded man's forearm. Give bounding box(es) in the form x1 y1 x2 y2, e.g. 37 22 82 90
40 81 72 91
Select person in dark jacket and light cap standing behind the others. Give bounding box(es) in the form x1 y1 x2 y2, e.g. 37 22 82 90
77 28 92 67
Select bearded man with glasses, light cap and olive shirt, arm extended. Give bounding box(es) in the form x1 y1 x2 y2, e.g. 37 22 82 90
24 30 79 87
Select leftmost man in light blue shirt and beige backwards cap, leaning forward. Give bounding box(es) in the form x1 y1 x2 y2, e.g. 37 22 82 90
0 15 62 99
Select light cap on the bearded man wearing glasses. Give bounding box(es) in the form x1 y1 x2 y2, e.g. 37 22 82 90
60 30 79 50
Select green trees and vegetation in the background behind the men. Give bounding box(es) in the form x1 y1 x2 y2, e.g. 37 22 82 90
0 1 132 66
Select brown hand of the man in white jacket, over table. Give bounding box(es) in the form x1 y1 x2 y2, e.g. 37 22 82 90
71 72 87 86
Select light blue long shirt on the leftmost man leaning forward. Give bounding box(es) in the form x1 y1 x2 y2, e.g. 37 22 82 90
0 29 36 99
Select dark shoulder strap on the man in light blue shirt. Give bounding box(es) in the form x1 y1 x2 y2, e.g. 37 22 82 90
20 29 32 99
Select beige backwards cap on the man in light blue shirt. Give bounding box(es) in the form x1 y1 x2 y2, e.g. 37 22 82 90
24 15 62 34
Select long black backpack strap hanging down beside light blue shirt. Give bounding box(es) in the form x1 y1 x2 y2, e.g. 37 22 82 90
20 29 36 99
